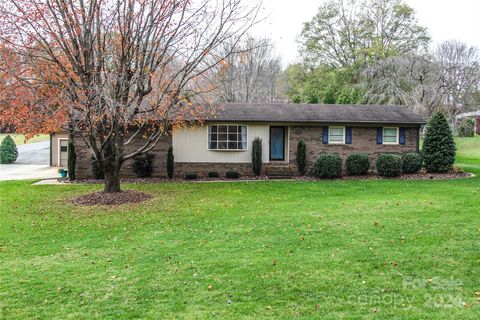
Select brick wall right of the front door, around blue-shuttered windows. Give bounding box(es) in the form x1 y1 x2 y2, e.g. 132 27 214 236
289 126 418 172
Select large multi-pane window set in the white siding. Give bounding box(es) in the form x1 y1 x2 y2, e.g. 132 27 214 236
208 125 247 150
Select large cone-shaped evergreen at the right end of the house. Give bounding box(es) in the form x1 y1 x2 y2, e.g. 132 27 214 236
422 112 456 172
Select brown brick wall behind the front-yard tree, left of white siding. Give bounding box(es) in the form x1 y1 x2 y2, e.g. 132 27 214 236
74 131 172 179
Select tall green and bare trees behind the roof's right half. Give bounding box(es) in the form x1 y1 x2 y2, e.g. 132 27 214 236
262 0 480 119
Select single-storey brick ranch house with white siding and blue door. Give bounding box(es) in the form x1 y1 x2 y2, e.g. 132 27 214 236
51 103 425 178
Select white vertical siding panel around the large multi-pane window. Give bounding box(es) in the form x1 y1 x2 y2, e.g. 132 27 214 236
172 123 270 163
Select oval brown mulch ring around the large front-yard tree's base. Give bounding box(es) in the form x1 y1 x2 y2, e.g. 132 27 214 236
72 190 152 206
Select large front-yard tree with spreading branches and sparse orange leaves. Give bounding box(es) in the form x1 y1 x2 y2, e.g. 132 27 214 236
0 0 258 192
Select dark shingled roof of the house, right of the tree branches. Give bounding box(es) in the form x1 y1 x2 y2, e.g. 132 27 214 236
206 103 425 125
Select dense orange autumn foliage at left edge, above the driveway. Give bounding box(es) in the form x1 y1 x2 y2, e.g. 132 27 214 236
0 45 68 139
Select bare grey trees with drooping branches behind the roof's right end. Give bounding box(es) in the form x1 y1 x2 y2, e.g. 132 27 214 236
361 41 480 118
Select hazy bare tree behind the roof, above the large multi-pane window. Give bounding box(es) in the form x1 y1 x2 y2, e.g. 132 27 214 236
210 37 281 103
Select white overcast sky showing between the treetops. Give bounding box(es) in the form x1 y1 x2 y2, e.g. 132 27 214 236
252 0 480 65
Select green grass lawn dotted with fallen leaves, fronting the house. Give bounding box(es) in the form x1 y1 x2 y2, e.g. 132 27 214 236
0 139 480 319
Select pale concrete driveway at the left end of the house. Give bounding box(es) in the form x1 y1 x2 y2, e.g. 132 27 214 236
0 141 58 180
